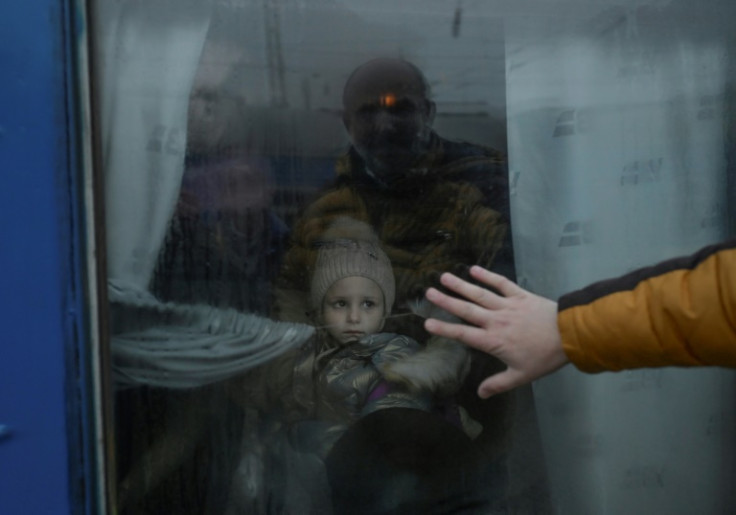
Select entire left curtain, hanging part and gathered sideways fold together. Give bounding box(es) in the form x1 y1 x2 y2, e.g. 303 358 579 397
94 0 314 388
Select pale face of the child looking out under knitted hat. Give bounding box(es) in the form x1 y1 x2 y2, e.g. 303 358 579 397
322 276 384 344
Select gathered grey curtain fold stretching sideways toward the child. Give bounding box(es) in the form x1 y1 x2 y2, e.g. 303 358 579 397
111 290 314 389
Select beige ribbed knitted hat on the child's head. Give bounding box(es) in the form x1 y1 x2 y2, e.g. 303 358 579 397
310 217 396 314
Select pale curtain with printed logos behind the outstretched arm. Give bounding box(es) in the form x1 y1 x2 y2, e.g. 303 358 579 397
506 2 736 515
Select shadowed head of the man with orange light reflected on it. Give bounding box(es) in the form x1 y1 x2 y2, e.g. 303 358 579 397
343 58 434 178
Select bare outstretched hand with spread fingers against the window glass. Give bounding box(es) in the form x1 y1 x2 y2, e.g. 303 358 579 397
424 266 569 398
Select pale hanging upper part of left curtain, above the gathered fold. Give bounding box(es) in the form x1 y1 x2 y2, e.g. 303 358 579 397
95 0 211 291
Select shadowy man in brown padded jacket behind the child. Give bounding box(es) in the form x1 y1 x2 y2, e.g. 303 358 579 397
277 58 514 330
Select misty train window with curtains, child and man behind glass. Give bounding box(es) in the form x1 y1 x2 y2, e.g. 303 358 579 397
92 0 736 514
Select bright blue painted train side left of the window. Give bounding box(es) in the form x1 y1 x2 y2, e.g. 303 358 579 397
0 0 104 514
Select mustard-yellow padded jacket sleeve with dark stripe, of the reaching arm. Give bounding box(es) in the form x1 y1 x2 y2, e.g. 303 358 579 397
557 241 736 372
